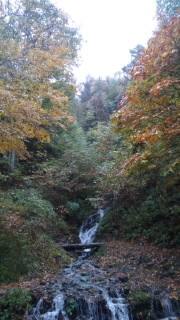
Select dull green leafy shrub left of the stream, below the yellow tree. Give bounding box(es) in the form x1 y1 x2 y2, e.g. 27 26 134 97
0 189 71 283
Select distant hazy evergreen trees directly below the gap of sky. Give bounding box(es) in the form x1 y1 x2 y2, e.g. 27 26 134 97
75 77 125 131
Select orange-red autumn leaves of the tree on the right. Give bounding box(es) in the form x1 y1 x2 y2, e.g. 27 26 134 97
113 17 180 175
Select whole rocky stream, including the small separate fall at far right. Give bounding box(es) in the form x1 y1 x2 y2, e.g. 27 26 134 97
28 209 178 320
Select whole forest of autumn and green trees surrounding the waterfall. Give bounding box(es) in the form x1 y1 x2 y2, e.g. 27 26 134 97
0 0 180 320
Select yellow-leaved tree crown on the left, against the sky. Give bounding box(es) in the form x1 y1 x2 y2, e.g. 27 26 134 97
0 0 79 157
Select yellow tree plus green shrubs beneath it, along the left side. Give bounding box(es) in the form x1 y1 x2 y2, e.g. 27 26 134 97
0 0 80 282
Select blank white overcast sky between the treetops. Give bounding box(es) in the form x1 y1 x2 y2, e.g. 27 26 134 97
53 0 156 81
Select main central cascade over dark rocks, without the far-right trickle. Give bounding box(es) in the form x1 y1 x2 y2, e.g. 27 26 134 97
29 209 131 320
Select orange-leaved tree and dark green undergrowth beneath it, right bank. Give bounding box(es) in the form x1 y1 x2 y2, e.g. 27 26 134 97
98 13 180 245
